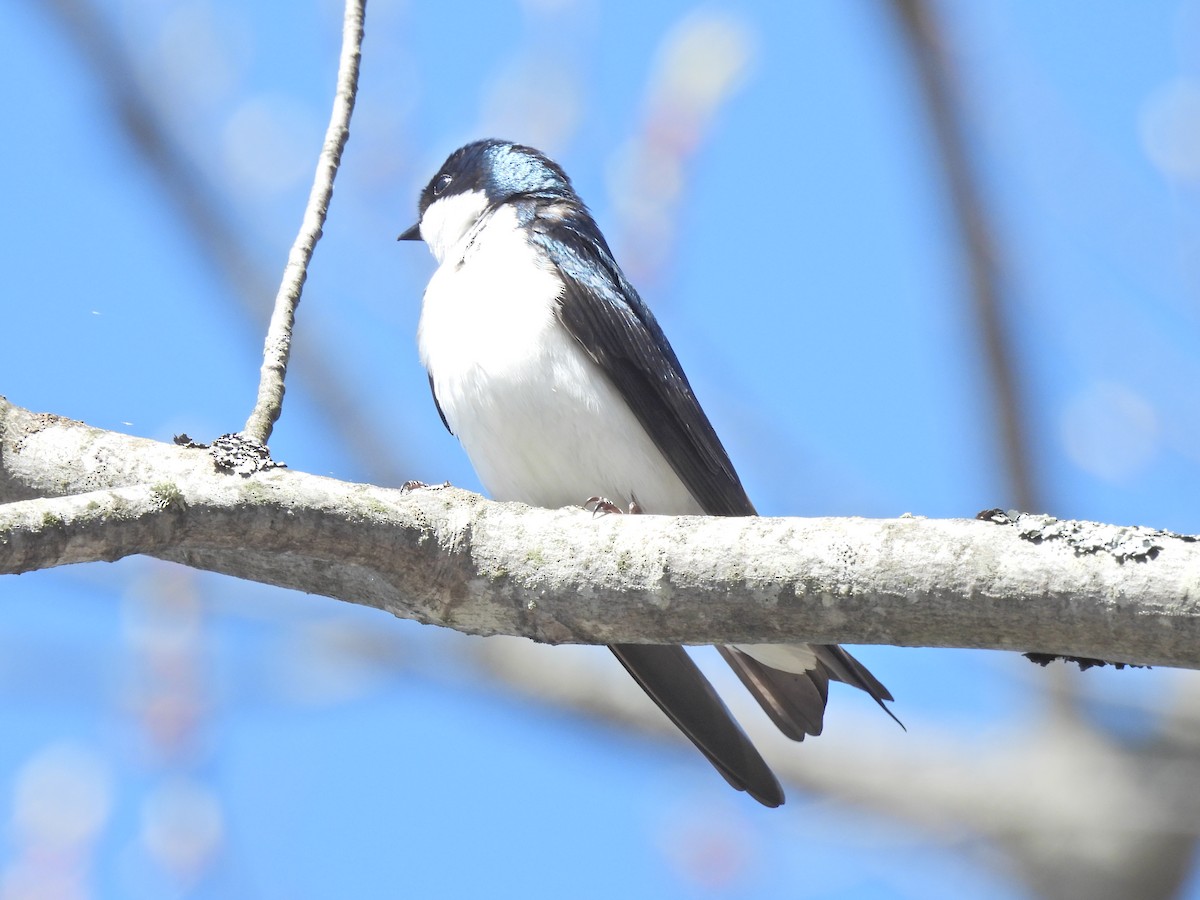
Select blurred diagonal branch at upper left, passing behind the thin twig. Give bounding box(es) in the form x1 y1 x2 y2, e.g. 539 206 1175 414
37 0 407 484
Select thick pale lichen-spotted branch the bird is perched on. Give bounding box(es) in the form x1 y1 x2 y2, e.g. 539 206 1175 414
0 400 1200 667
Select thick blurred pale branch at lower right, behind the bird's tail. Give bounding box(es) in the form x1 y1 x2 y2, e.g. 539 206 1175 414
468 638 1200 900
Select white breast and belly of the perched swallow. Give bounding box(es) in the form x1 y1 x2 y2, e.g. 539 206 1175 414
418 208 701 515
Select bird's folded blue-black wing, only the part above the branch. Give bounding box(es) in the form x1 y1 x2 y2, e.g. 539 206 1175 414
530 208 755 516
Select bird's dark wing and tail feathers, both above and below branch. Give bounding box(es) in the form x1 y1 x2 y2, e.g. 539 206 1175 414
522 202 899 806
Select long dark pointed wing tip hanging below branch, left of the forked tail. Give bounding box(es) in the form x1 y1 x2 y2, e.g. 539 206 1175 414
608 643 784 806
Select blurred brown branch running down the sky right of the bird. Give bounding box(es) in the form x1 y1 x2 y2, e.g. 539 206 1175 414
892 0 1044 510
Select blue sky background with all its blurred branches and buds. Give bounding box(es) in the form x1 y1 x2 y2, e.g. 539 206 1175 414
0 0 1200 900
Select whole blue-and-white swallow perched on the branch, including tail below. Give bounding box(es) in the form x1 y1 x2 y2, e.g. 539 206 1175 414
398 139 904 806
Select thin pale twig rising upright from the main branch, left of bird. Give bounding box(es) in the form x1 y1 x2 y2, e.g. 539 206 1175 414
241 0 366 444
